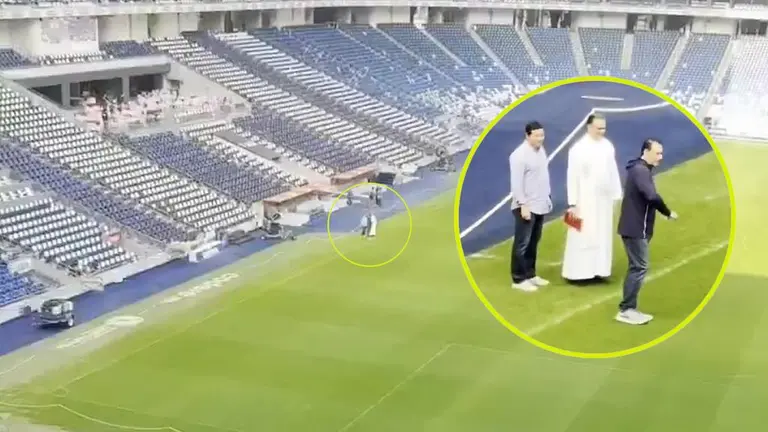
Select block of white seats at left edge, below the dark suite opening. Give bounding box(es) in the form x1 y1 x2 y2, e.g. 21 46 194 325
0 87 251 236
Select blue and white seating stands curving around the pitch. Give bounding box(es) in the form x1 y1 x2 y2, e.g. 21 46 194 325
0 5 752 312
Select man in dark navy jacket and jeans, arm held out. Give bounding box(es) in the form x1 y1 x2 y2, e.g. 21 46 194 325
616 139 677 325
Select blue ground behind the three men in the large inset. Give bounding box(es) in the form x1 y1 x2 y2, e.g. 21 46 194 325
459 82 712 255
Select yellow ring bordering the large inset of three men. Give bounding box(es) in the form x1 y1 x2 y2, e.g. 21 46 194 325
453 76 736 359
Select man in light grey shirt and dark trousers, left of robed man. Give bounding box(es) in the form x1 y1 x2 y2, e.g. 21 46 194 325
509 122 552 292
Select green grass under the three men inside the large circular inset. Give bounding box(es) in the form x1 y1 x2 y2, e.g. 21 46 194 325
468 148 731 353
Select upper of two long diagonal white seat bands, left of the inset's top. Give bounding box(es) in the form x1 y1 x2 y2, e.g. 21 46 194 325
215 33 460 154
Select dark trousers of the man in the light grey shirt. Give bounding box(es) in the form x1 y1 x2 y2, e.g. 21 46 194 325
511 208 544 283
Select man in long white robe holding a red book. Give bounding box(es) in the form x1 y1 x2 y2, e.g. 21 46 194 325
562 114 622 282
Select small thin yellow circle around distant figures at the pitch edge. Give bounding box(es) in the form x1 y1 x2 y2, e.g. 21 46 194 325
326 182 413 268
